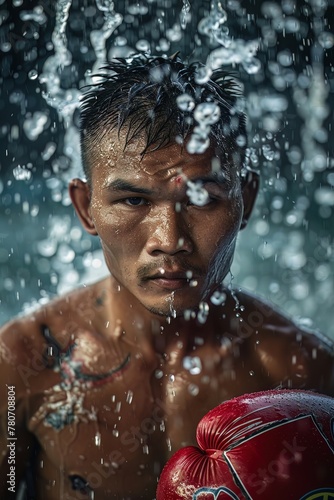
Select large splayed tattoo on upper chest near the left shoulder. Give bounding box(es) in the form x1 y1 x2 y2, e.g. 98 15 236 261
40 326 130 430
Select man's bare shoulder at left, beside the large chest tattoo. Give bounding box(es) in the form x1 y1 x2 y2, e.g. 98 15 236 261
0 282 107 398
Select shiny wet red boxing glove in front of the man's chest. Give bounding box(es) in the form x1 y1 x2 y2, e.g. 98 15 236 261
156 390 334 500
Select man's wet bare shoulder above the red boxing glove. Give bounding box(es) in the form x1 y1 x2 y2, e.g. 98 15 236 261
230 292 334 396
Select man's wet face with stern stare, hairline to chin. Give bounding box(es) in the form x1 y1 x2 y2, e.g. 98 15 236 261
81 133 253 316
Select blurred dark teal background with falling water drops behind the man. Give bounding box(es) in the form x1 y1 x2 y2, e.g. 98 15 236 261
0 0 334 339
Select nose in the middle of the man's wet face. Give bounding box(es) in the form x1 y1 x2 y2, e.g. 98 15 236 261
146 207 193 255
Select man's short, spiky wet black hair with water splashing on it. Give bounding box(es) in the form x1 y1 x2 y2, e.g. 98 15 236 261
80 54 246 180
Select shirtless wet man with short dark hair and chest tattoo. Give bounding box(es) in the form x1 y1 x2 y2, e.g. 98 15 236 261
0 52 334 500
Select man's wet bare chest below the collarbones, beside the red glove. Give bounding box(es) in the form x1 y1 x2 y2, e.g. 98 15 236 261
29 334 264 500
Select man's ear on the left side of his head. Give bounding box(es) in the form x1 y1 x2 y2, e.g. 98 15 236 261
68 179 98 236
